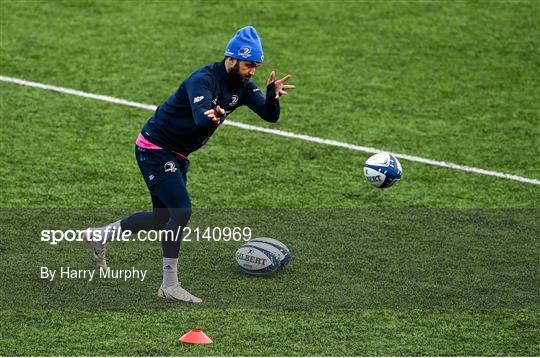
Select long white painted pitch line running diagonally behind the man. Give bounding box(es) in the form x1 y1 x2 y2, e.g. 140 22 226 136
0 76 540 185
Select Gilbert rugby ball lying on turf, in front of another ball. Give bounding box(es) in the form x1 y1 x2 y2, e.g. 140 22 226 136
236 242 281 276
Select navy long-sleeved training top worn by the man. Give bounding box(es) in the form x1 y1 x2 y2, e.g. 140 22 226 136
141 61 279 156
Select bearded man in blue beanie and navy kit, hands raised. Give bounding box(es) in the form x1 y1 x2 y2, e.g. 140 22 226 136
85 26 295 303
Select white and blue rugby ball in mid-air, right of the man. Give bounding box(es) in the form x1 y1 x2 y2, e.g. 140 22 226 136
364 153 403 189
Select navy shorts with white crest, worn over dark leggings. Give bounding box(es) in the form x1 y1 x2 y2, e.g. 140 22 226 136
135 145 189 190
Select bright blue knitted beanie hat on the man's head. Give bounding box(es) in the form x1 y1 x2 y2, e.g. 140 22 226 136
224 26 264 62
